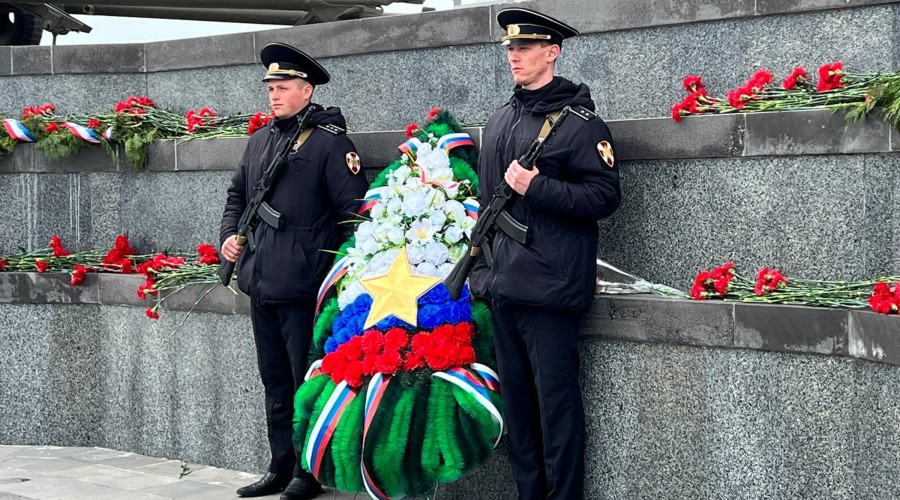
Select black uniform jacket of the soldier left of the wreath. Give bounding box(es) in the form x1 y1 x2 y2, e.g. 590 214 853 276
219 104 368 303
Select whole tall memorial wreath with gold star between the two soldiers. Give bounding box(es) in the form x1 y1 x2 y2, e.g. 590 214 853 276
294 108 504 499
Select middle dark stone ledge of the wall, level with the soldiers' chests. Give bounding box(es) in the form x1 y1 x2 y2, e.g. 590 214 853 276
0 110 888 174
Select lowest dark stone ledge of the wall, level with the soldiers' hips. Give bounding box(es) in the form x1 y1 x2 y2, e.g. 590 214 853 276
0 272 900 366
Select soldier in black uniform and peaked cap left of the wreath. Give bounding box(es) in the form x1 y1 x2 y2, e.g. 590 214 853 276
219 43 368 500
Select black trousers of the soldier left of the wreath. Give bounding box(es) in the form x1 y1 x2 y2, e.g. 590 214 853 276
250 301 316 478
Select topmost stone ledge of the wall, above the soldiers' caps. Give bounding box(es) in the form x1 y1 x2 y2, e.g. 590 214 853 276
0 0 897 75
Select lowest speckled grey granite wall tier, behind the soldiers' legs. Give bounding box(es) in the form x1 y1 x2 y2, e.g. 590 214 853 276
0 294 900 500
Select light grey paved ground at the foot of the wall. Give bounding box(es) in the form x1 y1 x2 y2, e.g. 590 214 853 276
0 445 358 500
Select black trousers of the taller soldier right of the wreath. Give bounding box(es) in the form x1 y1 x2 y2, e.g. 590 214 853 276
491 303 584 500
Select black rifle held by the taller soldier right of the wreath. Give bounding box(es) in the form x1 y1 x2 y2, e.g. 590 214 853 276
444 106 572 300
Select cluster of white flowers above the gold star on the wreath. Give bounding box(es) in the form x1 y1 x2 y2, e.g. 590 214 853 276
338 138 475 309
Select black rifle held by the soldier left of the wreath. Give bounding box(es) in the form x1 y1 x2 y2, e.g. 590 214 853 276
219 104 316 286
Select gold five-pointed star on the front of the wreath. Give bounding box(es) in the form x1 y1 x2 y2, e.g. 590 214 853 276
359 247 441 328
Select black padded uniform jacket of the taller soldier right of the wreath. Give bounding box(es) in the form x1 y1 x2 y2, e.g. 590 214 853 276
471 77 621 311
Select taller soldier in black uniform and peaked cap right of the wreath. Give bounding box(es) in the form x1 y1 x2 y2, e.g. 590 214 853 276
470 8 621 500
